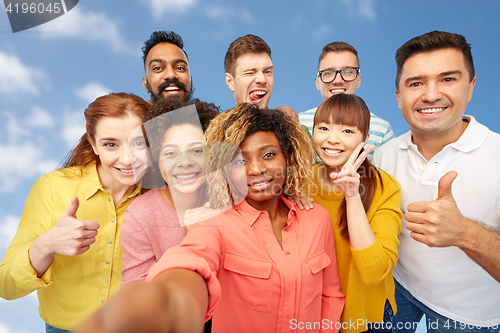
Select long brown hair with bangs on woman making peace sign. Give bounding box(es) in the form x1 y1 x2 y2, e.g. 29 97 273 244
313 94 383 239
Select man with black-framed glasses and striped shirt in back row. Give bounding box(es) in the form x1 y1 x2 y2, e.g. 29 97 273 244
299 42 394 158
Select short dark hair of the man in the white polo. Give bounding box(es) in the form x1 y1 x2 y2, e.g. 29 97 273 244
396 31 476 90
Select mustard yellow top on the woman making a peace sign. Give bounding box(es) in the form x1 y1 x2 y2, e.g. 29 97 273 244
310 164 403 333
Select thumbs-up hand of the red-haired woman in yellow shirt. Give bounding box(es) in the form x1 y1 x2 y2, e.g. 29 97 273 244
29 196 99 277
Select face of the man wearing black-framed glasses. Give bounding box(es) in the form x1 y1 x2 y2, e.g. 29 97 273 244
315 51 361 101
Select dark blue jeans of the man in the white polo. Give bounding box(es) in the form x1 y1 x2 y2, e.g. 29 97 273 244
392 279 500 333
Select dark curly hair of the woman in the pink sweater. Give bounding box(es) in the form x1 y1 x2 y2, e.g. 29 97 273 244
142 99 220 188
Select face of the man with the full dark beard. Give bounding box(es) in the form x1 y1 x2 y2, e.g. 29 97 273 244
142 43 192 103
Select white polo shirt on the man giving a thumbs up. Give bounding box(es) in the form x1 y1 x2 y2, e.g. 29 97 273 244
373 116 500 326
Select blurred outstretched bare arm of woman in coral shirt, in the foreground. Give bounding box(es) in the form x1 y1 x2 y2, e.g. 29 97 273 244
74 268 208 333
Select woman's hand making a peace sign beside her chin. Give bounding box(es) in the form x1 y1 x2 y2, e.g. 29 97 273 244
330 142 375 200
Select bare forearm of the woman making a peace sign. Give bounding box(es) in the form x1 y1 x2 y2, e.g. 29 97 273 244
346 195 376 249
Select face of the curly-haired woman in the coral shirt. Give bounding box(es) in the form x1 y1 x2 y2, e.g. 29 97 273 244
240 132 287 210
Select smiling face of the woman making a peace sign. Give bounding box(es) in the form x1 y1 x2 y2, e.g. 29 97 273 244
313 122 368 171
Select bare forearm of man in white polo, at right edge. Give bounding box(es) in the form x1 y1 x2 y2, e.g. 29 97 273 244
456 219 500 282
